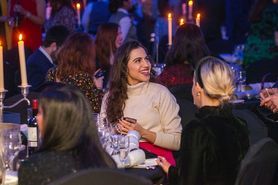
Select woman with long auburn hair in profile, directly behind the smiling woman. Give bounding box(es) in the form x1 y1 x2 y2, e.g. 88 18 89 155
95 23 123 89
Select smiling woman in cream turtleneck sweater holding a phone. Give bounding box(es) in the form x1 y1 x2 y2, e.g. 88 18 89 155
101 41 182 164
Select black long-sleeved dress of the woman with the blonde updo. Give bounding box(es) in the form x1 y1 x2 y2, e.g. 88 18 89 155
169 106 249 185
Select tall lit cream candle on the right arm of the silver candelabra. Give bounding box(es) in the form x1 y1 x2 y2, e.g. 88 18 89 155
18 34 28 87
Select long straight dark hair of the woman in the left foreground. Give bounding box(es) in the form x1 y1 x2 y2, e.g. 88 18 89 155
39 85 115 168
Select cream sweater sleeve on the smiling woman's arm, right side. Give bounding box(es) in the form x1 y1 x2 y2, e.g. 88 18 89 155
154 87 182 150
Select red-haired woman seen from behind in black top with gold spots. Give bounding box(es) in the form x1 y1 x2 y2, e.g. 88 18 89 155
47 33 103 112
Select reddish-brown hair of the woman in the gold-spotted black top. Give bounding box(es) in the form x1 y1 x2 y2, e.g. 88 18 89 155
56 33 96 80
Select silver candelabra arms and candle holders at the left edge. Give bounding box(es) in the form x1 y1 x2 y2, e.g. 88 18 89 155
0 85 31 123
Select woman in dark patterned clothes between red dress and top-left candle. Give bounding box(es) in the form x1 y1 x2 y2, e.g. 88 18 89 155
44 0 77 32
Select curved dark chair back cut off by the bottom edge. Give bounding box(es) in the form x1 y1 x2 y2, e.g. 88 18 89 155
49 169 152 185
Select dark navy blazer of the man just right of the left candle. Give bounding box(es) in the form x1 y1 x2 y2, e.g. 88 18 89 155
27 49 54 91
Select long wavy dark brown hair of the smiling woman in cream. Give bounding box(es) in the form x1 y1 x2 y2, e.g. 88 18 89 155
106 41 147 123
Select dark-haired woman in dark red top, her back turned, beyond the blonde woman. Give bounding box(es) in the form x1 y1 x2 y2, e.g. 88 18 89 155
157 23 209 88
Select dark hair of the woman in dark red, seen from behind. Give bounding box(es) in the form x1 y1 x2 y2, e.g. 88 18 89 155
165 23 210 68
